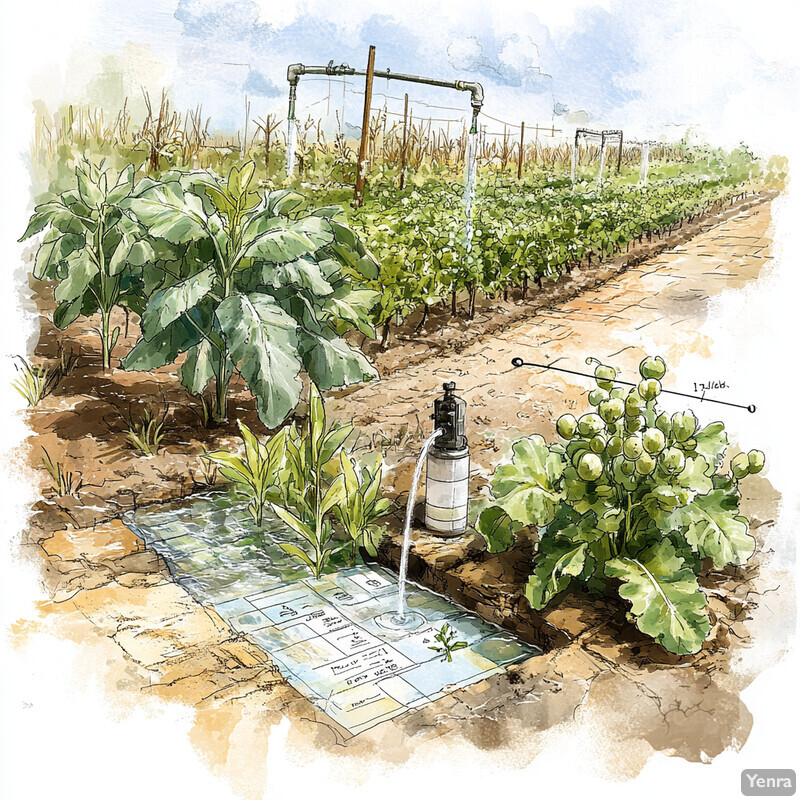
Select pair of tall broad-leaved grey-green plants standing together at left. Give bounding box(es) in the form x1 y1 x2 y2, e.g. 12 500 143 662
23 161 379 428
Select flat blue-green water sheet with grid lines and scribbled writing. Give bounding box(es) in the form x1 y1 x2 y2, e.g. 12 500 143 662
125 492 542 735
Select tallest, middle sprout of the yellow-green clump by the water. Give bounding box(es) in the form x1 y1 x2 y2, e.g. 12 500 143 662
272 384 353 578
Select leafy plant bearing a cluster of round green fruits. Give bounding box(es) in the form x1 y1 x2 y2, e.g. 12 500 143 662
476 358 764 654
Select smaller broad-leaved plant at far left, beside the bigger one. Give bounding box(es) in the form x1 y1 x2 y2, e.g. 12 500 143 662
21 160 153 369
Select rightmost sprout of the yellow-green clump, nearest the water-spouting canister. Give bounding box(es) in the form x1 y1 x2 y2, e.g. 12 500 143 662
334 450 394 565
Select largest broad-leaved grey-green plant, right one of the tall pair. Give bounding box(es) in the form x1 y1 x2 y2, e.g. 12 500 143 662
123 162 378 428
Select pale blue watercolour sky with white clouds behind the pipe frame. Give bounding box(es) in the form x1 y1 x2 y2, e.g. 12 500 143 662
15 0 800 147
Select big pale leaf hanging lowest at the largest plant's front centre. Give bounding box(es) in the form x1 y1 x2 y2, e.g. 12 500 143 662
215 293 302 428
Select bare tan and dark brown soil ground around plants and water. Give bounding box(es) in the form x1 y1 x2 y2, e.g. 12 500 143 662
15 180 779 785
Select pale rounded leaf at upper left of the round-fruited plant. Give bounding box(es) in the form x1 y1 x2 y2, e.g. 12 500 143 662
492 435 564 526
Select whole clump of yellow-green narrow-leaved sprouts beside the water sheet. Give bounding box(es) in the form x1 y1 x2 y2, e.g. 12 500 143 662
203 383 394 578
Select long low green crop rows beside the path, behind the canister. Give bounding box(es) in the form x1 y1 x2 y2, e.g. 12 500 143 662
350 170 747 324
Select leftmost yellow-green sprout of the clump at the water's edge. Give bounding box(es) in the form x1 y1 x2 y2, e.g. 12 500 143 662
201 421 286 525
